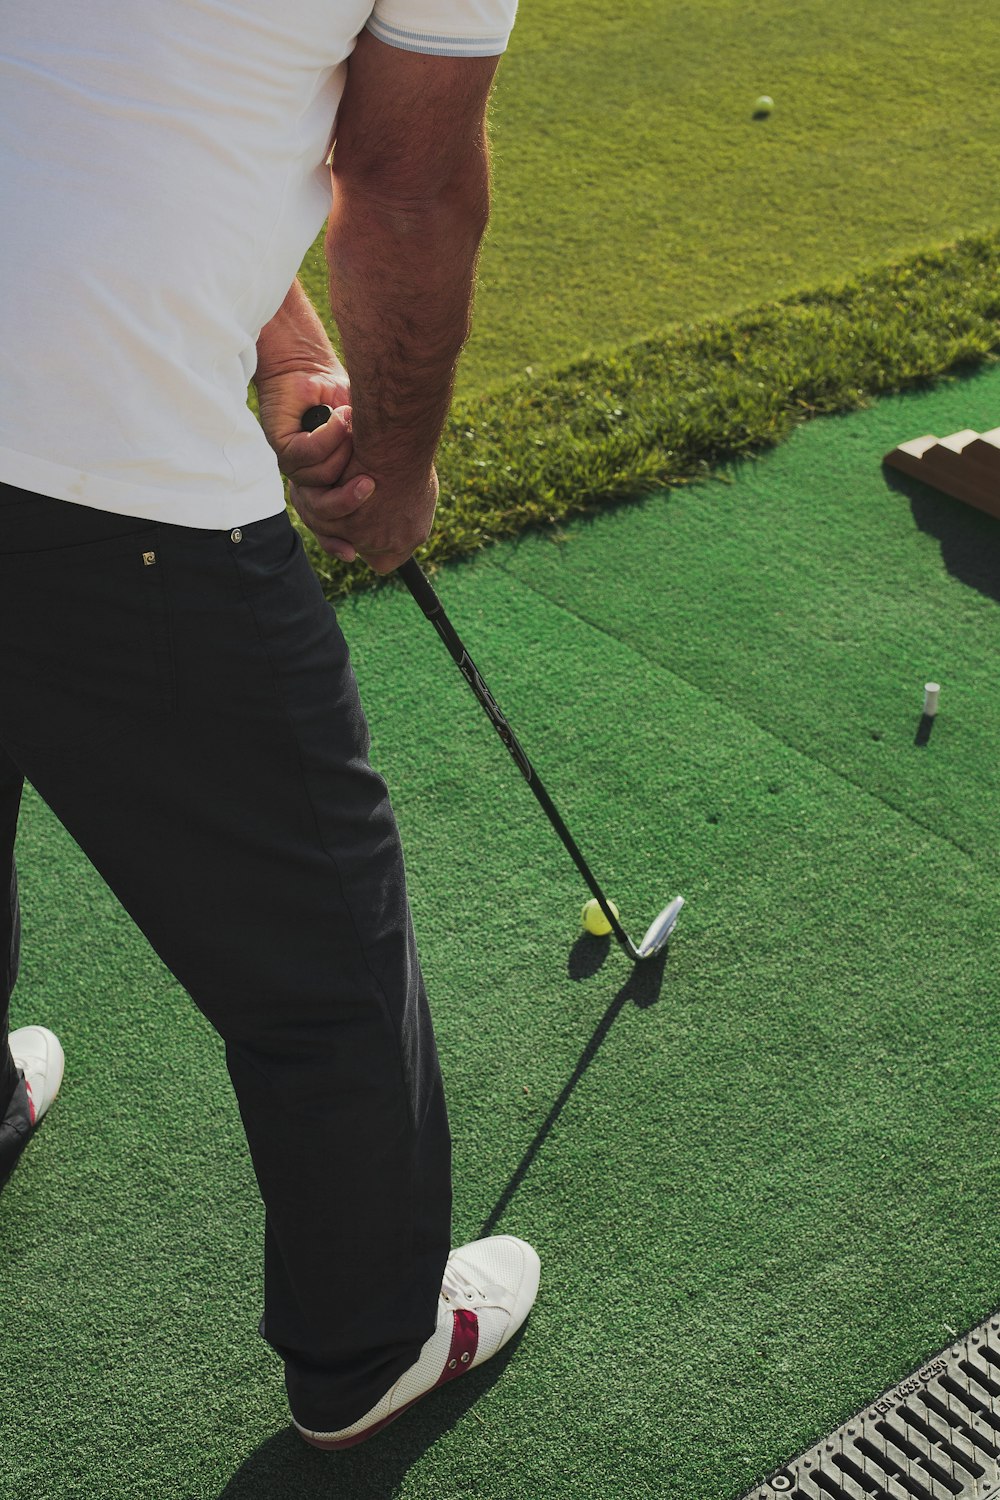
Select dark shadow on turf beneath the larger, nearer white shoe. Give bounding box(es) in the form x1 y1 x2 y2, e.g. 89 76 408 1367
217 1316 531 1500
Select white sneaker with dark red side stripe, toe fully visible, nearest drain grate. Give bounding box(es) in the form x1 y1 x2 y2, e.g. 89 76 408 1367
292 1235 541 1448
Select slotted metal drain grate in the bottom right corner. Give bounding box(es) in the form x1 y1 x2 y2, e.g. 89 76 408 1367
744 1314 1000 1500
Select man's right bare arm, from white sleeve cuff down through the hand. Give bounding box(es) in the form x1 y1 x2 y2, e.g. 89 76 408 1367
292 32 509 573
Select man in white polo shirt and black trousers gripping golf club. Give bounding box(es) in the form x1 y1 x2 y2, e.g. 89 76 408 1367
0 0 538 1448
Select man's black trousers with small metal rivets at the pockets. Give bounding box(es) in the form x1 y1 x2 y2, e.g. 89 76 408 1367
0 486 451 1431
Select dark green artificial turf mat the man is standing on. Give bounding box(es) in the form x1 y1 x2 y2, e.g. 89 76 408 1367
0 345 1000 1500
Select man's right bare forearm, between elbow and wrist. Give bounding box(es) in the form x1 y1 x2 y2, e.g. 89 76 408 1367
325 161 489 474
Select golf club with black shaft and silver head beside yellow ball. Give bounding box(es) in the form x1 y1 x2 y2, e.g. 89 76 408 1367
301 407 684 962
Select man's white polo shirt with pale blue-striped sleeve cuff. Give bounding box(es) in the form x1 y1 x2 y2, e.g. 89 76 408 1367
0 0 517 528
